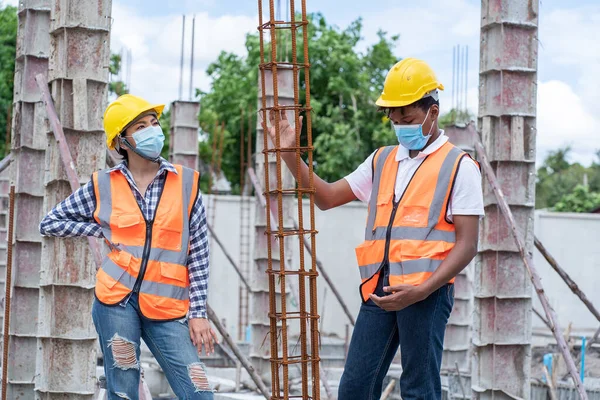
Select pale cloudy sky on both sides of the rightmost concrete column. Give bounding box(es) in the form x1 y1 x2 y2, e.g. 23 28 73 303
356 0 600 165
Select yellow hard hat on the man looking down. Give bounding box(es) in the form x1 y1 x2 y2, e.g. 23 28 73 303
376 58 444 107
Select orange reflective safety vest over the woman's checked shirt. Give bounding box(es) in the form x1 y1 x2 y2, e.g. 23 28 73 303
92 165 200 321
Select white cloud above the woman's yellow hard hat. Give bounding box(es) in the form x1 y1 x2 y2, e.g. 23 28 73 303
111 1 256 104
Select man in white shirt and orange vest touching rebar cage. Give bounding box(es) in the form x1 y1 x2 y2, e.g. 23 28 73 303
269 58 483 400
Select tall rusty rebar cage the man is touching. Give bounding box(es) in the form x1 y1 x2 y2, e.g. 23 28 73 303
258 0 320 400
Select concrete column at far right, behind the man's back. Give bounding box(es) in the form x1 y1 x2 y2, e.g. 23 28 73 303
472 0 539 399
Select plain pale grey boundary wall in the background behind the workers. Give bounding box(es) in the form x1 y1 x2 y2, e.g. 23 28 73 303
204 196 600 340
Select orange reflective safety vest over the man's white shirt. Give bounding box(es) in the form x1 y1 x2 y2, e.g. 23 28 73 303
356 142 468 302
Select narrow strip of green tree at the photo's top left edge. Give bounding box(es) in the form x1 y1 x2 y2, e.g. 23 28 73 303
0 6 18 158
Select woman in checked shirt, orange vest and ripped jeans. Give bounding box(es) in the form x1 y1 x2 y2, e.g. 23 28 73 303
40 94 217 400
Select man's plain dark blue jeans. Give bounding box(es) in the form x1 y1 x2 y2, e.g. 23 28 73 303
338 278 454 400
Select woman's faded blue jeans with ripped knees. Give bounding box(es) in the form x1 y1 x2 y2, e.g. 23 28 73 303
92 294 213 400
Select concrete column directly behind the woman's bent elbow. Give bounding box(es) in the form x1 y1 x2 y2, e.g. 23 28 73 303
34 0 112 399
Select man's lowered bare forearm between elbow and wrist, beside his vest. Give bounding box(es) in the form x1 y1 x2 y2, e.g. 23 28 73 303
420 242 477 297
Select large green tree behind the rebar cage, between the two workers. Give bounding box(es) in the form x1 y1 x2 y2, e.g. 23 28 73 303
197 14 398 192
